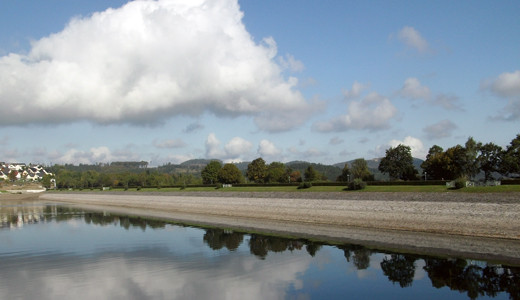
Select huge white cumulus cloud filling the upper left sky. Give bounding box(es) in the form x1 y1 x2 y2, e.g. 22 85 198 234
0 0 316 132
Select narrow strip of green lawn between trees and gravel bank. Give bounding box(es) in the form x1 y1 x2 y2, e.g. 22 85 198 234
48 185 520 193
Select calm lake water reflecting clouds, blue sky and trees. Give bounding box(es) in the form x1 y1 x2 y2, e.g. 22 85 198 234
0 202 520 300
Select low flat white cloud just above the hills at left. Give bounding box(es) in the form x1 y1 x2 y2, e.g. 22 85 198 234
47 147 140 165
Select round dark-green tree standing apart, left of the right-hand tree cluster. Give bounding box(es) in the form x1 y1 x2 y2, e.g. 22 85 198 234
379 144 418 180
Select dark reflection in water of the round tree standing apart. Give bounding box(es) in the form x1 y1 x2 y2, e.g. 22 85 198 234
381 254 416 288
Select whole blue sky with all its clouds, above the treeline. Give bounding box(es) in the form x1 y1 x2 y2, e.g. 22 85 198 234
0 0 520 166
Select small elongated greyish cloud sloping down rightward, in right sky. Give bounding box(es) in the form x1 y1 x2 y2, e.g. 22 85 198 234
397 77 463 111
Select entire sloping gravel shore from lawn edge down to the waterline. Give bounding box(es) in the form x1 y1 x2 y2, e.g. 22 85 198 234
6 192 520 266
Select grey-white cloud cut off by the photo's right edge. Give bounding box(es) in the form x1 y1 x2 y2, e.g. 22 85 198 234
480 71 520 121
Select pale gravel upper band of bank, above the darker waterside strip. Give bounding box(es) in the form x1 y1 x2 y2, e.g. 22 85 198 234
40 192 520 240
